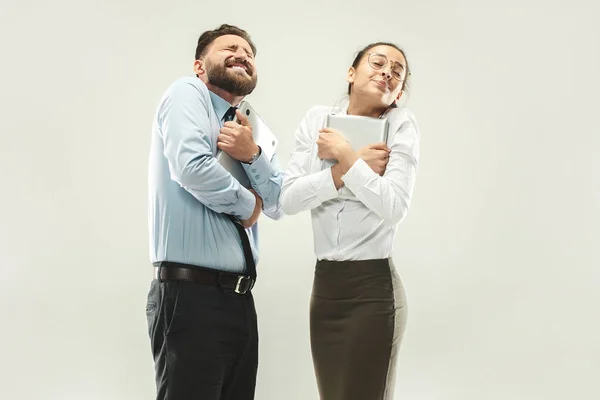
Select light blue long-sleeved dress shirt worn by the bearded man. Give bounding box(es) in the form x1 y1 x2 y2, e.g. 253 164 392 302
148 76 283 273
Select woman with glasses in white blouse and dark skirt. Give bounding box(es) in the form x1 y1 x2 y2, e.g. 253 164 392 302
281 43 419 400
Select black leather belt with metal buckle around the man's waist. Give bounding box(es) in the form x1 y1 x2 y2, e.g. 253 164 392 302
154 261 255 294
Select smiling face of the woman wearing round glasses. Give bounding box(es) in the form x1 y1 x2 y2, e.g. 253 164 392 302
346 46 406 107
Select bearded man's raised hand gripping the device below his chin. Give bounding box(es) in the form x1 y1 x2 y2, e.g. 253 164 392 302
217 110 259 162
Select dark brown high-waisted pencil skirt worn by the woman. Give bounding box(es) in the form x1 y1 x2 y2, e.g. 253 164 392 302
310 259 407 400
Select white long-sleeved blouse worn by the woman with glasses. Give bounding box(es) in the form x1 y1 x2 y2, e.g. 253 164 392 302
280 106 419 261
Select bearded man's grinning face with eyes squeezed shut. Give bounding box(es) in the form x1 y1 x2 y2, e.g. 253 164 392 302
202 35 258 96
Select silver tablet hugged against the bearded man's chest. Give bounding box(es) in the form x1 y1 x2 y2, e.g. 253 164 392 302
217 100 278 188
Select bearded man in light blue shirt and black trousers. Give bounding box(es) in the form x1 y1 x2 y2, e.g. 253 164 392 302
146 25 283 400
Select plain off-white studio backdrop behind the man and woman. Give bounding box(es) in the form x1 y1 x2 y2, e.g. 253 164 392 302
0 0 600 400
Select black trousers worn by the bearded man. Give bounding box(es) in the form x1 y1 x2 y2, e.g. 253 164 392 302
146 280 258 400
